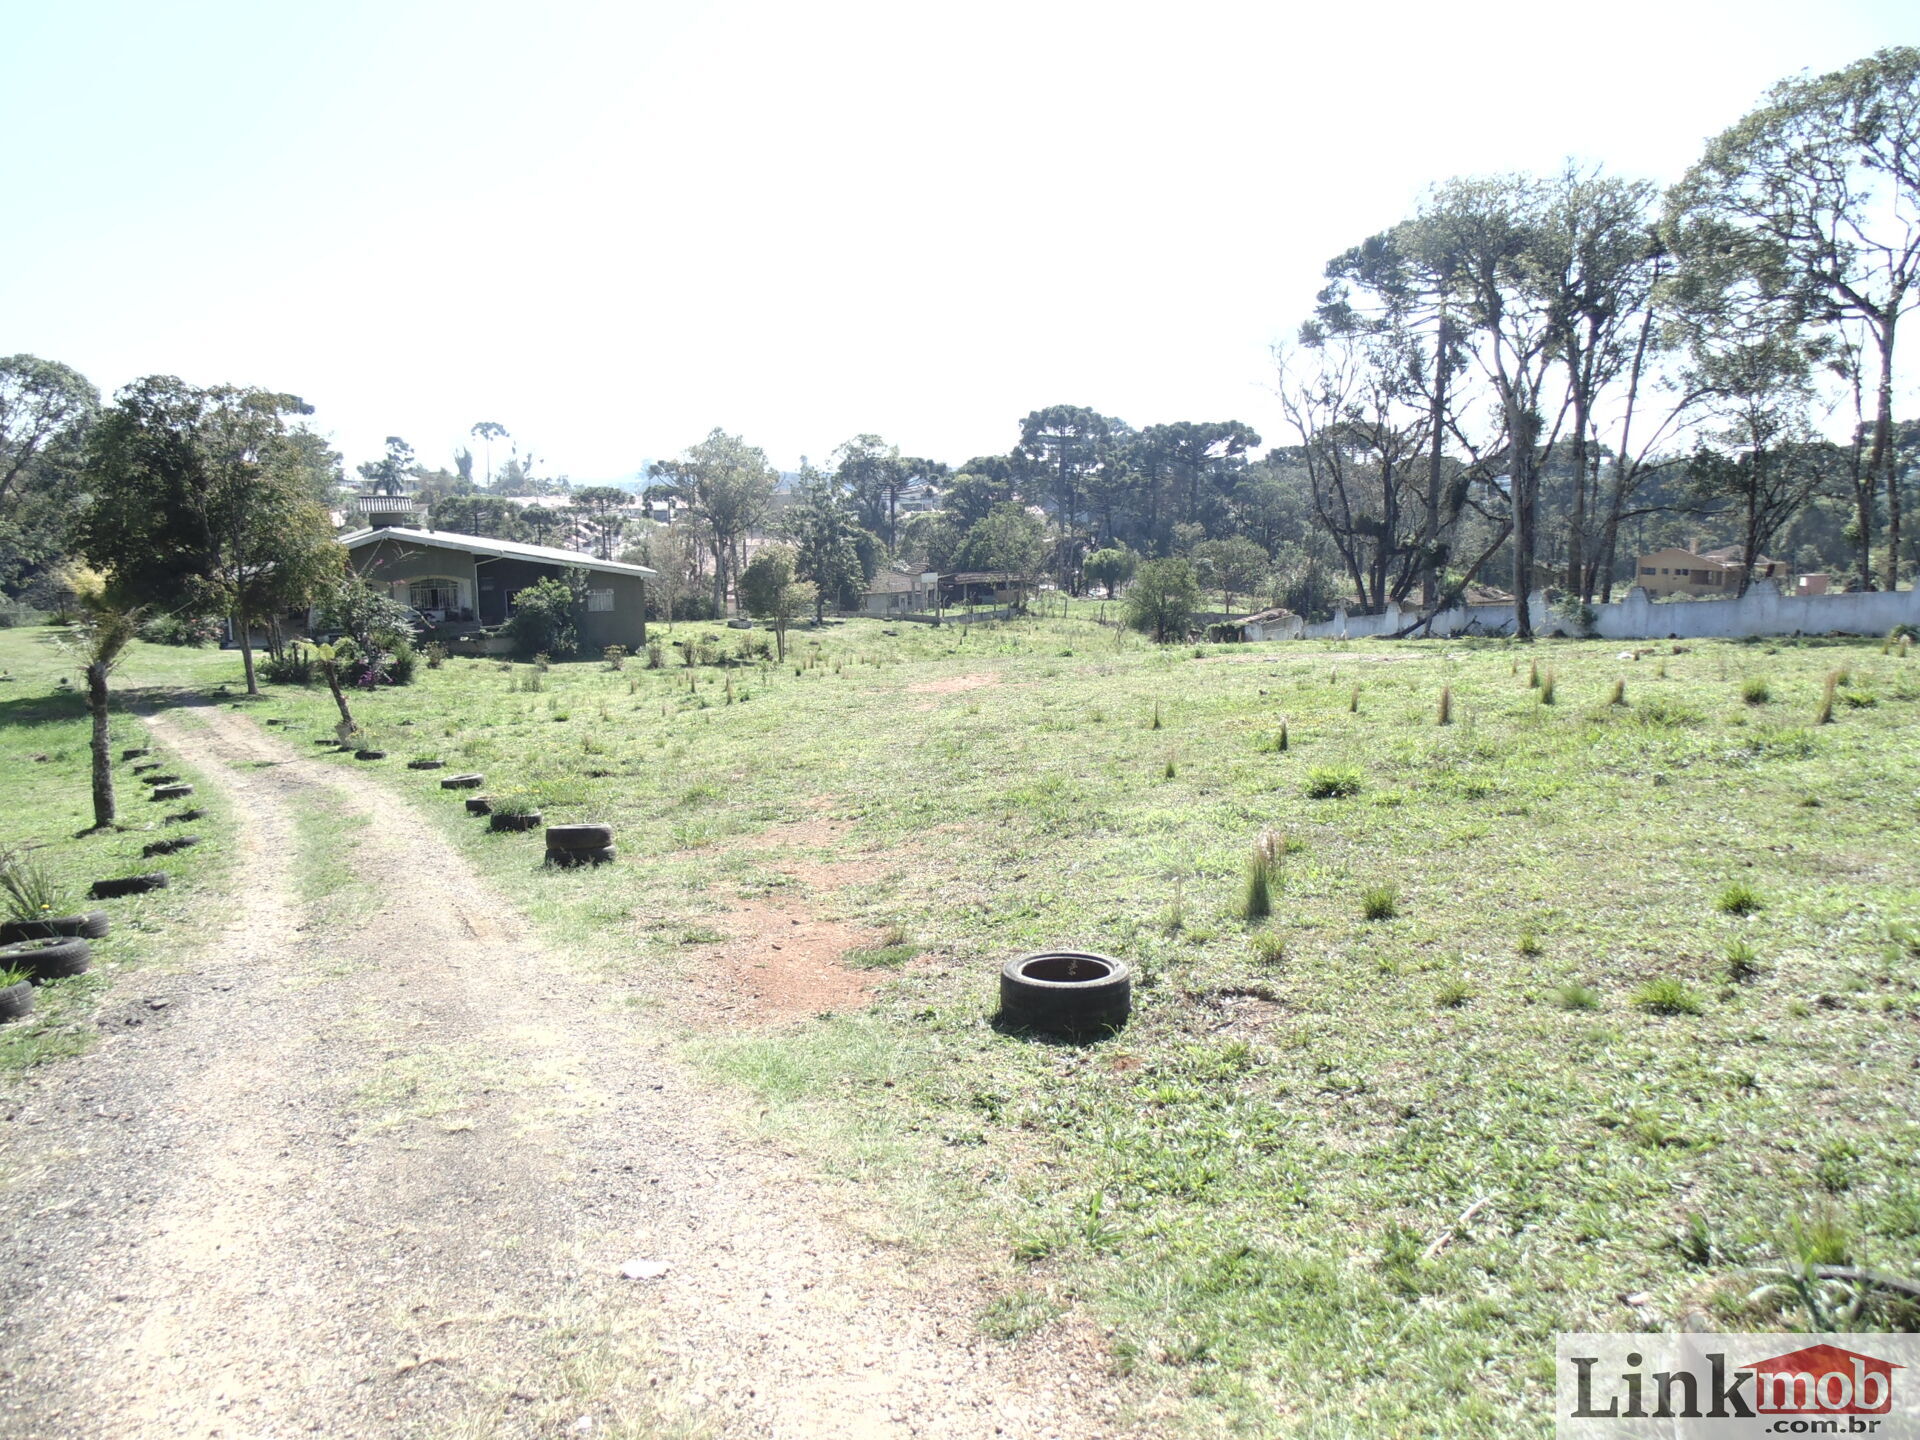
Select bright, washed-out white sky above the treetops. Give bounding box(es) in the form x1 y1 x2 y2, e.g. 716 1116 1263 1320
0 0 1920 484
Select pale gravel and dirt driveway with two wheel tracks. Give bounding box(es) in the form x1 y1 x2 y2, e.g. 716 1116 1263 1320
0 708 1121 1440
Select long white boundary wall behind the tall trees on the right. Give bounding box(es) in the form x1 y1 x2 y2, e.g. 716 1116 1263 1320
1246 580 1920 639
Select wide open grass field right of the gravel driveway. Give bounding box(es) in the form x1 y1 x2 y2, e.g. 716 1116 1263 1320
0 614 1920 1434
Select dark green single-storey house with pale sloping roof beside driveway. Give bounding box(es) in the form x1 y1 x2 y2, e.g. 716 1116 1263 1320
340 524 655 649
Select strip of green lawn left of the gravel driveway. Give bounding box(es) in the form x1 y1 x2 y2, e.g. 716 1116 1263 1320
0 628 240 1092
